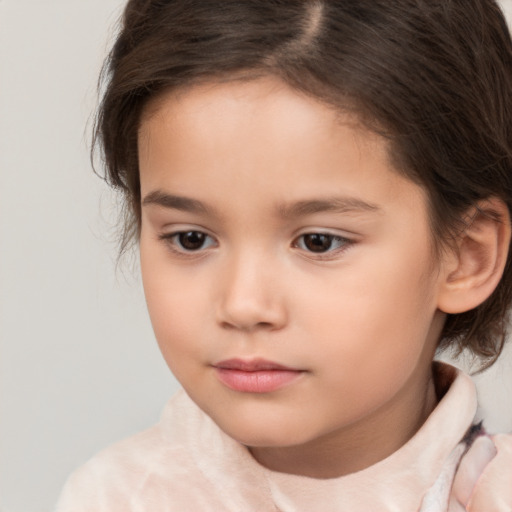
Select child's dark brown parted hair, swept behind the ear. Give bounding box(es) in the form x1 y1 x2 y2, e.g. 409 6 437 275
93 0 512 366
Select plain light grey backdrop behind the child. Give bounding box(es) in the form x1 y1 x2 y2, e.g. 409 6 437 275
0 0 512 512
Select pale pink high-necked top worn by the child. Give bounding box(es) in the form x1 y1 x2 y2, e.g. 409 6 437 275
57 364 512 512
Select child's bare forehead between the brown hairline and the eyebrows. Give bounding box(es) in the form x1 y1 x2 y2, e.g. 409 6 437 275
139 78 428 223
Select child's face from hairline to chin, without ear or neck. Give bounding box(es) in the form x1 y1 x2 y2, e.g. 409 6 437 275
139 78 442 472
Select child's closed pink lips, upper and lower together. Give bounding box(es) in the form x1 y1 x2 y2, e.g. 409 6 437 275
214 359 304 393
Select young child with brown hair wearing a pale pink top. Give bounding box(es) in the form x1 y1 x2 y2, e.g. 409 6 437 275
58 0 512 512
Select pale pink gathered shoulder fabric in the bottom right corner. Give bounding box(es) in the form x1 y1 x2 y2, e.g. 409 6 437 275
450 434 512 512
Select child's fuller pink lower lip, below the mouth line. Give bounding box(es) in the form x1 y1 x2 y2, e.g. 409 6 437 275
216 368 303 393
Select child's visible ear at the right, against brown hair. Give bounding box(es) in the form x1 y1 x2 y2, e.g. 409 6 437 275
438 197 511 314
